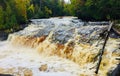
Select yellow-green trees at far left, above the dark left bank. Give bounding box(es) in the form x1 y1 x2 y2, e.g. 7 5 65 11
0 0 29 30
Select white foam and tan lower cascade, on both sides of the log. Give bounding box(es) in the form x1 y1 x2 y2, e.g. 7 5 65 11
0 39 119 76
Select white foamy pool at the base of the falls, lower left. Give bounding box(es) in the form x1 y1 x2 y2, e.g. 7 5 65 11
0 42 86 76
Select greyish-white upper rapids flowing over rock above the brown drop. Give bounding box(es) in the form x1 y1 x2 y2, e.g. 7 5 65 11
8 17 111 44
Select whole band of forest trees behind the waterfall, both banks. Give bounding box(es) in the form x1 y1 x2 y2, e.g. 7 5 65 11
0 0 120 30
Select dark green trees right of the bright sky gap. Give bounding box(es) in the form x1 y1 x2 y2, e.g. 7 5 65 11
70 0 120 20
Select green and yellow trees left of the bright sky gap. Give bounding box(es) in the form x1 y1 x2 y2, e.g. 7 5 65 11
0 0 69 29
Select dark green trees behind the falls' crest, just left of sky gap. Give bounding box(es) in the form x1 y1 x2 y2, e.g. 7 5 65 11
31 0 69 18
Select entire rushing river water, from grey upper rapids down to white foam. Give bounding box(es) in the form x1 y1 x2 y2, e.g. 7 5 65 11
0 17 120 76
